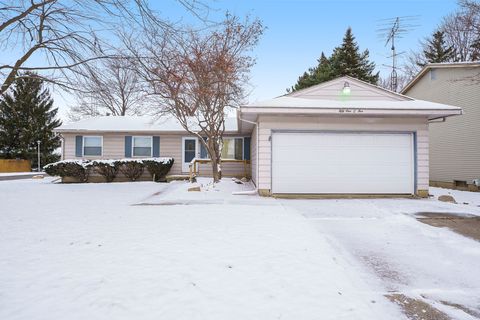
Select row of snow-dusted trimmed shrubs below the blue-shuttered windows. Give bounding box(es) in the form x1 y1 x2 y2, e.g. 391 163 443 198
44 158 174 182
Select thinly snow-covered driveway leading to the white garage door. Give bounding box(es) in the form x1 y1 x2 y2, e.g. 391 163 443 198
282 193 480 319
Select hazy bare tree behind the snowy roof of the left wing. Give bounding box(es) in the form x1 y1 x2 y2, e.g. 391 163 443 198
69 58 148 120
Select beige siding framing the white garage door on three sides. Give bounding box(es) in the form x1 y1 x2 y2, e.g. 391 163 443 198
258 116 428 194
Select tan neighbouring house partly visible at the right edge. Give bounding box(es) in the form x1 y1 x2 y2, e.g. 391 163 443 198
402 62 480 190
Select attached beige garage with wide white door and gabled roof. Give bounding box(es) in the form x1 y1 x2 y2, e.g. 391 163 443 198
238 76 462 197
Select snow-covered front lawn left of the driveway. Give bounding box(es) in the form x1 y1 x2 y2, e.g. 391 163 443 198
0 179 404 320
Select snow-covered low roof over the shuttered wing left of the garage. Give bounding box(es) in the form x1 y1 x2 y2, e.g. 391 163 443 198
55 116 237 132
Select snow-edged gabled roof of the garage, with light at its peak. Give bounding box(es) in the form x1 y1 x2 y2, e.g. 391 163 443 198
240 76 462 121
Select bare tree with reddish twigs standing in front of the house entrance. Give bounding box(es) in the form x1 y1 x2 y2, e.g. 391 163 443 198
125 15 264 182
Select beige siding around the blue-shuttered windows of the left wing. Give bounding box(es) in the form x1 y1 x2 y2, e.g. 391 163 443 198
62 132 251 177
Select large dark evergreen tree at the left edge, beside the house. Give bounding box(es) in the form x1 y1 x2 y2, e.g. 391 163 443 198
0 74 61 167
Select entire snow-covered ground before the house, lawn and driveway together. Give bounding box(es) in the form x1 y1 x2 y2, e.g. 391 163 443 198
0 178 480 320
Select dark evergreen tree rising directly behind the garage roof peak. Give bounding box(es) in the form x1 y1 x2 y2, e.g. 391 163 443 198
287 28 379 91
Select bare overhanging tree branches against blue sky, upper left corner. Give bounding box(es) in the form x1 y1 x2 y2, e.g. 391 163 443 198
0 0 206 95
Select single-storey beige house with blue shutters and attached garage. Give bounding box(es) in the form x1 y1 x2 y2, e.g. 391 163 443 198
57 76 462 196
